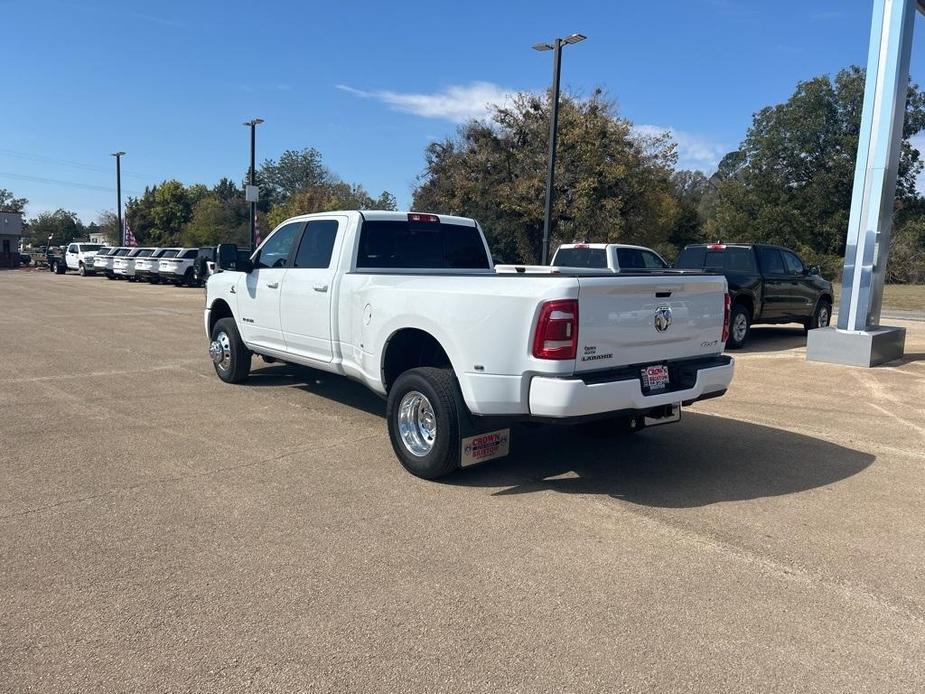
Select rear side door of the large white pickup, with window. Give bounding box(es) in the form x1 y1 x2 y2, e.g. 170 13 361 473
280 217 347 362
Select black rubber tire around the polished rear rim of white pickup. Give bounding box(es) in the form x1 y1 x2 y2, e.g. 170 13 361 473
386 366 460 480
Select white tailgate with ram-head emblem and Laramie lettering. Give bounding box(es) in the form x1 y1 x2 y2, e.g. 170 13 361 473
575 275 726 372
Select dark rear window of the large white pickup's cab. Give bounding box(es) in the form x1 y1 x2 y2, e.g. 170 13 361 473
357 220 488 270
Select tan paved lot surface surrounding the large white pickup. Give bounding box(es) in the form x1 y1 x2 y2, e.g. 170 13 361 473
0 272 925 692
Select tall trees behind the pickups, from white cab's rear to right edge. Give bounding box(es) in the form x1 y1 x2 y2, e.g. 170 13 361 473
414 67 925 282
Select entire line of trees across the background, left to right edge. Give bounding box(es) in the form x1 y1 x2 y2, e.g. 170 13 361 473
0 67 925 282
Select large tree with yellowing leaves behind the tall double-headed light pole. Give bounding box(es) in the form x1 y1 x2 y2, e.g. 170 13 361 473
414 90 678 263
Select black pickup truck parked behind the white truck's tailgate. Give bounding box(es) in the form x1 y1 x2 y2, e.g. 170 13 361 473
674 243 833 349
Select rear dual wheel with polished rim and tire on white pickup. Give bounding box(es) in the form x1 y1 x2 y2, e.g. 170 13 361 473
386 367 460 480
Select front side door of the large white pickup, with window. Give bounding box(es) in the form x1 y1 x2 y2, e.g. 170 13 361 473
236 222 303 350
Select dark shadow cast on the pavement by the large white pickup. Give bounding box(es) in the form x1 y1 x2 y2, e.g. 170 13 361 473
242 362 875 508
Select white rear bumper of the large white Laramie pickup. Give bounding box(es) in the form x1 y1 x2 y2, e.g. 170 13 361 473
530 356 735 419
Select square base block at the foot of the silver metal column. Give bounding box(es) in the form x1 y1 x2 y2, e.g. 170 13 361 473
806 325 906 367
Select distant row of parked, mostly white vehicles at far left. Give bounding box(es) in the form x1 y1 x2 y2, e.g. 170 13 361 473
48 242 215 287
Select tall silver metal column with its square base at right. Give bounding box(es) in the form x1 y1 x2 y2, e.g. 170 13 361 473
806 0 925 366
